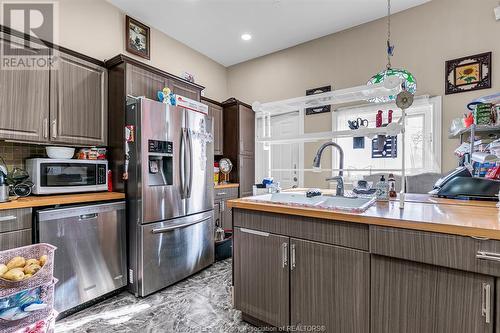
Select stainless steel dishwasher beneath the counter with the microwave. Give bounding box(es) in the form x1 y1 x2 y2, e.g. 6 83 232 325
37 202 127 312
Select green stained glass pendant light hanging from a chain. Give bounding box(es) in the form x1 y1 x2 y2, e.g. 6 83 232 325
367 0 417 103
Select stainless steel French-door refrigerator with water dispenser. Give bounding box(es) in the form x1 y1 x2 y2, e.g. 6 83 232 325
126 98 214 296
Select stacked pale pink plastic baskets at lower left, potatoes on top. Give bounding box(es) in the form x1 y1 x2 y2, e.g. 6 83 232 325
0 243 57 333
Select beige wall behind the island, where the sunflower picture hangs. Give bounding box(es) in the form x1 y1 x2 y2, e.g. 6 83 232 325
228 0 500 186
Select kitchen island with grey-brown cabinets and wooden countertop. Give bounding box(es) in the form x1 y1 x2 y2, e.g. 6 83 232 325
229 195 500 333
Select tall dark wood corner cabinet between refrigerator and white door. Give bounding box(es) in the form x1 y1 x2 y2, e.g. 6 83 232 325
222 98 255 197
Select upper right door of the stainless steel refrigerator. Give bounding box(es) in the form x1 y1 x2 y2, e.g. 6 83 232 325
185 110 214 215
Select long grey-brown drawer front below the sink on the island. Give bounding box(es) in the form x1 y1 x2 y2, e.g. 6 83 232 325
233 208 369 251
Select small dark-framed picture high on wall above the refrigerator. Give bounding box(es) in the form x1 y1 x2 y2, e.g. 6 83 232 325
125 16 151 60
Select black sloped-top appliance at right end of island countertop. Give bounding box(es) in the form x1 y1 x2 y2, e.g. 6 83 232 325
429 166 500 200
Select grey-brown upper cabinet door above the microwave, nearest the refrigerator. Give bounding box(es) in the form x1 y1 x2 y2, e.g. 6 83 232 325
50 51 108 146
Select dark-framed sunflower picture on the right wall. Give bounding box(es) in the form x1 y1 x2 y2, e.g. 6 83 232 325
445 52 491 95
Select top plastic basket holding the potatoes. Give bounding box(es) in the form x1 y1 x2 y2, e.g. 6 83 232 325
0 243 57 297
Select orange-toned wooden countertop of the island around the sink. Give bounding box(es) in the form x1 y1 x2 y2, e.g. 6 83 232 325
228 194 500 240
